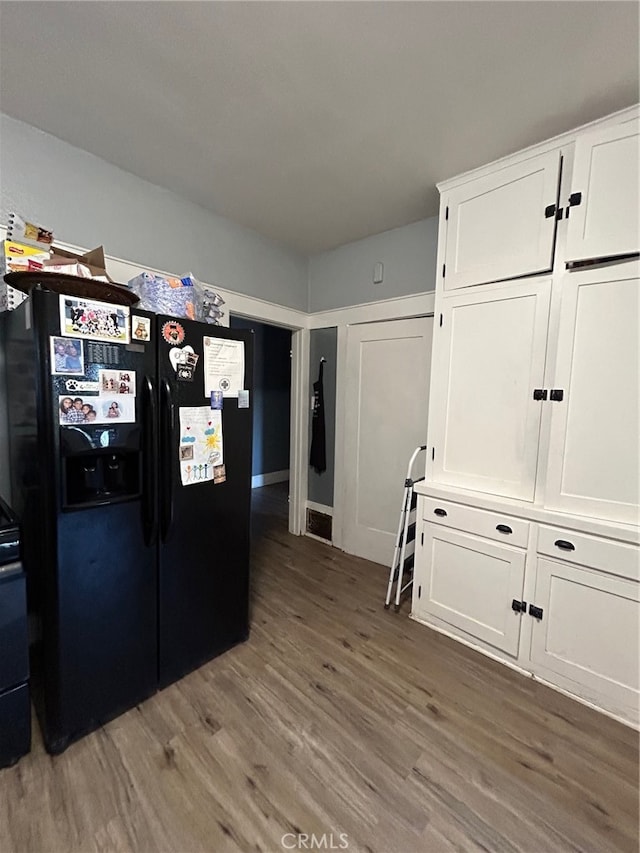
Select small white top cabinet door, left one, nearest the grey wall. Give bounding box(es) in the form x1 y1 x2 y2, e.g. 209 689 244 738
444 151 561 290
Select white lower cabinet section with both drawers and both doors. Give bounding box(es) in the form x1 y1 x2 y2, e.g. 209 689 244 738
412 506 640 723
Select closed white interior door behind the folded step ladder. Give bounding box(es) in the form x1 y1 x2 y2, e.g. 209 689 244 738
342 317 433 565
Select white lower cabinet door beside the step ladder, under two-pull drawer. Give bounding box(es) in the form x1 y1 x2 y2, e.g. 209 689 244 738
414 523 526 657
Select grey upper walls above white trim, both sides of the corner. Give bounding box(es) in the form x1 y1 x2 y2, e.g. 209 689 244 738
0 114 438 496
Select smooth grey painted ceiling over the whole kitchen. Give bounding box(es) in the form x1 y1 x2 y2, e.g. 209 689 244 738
0 0 639 254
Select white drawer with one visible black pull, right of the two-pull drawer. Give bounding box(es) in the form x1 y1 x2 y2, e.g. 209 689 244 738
538 524 640 580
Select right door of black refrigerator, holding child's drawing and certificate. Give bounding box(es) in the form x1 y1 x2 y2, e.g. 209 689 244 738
157 317 253 687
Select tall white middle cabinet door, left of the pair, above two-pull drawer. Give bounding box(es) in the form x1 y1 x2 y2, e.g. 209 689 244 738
429 280 551 501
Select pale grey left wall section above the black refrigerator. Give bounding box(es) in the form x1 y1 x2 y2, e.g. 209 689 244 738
0 115 307 311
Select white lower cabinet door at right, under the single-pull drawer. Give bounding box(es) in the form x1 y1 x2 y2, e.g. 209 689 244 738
531 558 640 721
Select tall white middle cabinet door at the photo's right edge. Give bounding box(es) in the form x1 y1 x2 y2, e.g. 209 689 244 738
545 264 640 522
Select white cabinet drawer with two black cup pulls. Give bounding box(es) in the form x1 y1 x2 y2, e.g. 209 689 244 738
424 497 529 548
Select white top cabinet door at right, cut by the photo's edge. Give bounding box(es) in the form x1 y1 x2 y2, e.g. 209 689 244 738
562 121 640 262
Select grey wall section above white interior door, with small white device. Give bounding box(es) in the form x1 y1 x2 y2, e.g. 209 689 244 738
309 216 438 312
